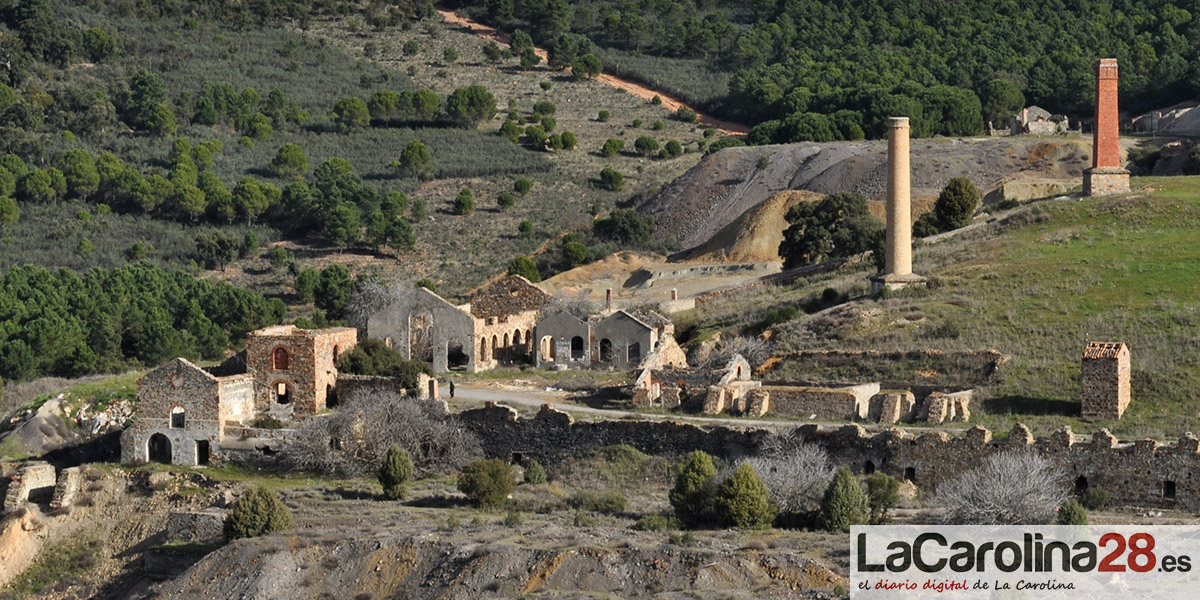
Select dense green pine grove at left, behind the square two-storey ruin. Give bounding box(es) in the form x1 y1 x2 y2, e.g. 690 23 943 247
0 262 286 380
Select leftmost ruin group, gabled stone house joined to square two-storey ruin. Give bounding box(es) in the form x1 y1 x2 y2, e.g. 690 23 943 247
121 325 358 466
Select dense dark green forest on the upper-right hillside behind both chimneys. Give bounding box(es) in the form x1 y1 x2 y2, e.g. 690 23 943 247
453 0 1200 143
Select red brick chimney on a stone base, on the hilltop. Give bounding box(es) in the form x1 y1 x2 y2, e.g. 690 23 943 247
1084 59 1129 196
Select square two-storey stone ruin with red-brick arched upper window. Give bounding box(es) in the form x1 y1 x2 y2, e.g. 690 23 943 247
246 325 358 416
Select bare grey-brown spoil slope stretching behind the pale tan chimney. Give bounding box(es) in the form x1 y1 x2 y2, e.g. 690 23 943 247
638 137 1091 250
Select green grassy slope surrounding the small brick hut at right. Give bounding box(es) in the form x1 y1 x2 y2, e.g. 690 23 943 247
679 178 1200 438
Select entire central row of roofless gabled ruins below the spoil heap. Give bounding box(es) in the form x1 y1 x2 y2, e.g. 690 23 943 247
367 275 686 373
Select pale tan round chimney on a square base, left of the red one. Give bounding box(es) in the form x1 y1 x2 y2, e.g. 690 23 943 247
871 116 925 293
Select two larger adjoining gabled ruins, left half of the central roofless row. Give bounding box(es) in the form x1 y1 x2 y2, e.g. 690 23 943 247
367 275 551 373
